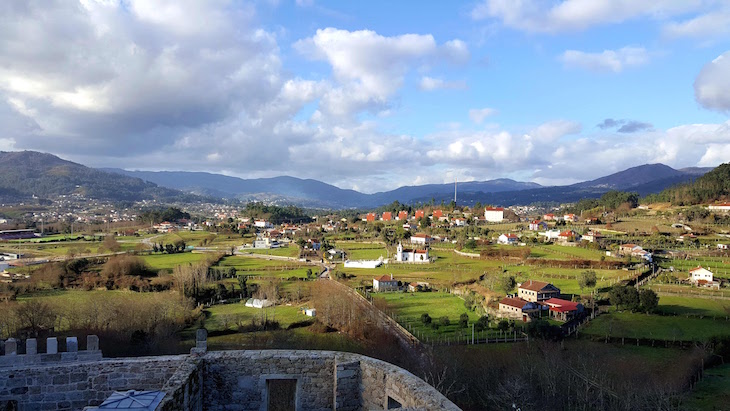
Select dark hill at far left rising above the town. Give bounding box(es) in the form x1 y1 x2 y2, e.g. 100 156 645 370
0 151 209 201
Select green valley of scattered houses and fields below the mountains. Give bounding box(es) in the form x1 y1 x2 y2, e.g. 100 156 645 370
0 199 730 408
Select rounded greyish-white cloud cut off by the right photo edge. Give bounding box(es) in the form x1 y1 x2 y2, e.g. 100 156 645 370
694 51 730 113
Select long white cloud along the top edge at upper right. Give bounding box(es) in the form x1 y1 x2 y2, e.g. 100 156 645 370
471 0 705 33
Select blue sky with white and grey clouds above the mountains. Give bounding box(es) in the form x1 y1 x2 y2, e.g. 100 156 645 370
0 0 730 192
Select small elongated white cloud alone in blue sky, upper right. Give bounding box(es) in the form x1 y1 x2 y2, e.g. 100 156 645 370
560 47 649 73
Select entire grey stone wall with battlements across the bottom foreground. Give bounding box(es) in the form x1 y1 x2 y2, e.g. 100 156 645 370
0 330 458 411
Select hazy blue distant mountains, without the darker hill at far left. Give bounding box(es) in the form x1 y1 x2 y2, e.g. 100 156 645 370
104 164 711 208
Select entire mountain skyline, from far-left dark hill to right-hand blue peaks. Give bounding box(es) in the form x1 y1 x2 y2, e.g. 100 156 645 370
0 151 711 209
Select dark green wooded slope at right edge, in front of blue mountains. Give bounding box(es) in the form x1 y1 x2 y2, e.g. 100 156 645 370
645 163 730 205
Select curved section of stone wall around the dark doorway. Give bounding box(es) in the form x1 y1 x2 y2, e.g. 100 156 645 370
203 350 459 411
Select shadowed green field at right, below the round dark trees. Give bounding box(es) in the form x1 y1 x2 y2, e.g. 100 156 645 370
581 312 730 341
